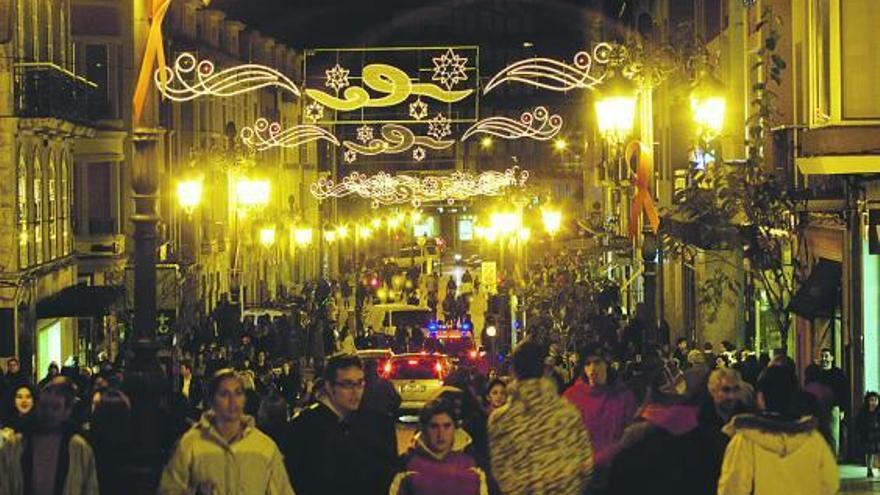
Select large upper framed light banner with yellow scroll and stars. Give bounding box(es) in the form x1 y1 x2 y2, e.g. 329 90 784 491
303 46 480 125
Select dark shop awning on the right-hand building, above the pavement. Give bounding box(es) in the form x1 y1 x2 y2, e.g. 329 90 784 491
788 258 841 320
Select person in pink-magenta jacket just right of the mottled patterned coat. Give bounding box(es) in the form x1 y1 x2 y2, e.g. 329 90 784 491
564 344 636 469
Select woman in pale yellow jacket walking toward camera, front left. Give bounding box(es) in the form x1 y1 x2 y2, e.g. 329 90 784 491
159 369 294 495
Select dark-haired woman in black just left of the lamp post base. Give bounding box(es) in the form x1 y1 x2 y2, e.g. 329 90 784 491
86 388 133 495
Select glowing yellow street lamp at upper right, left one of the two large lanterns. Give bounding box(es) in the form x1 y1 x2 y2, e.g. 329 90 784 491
595 71 636 144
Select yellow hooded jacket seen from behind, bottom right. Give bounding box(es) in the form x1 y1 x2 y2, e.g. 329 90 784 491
718 414 840 495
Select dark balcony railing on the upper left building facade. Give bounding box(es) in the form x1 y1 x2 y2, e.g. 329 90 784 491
15 62 98 124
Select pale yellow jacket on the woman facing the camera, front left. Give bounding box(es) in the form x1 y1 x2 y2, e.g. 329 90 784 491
159 411 293 495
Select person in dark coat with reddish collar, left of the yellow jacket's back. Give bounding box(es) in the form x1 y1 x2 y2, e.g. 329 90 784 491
607 357 709 495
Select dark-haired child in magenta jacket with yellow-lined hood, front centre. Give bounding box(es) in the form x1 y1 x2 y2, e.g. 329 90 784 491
388 399 488 495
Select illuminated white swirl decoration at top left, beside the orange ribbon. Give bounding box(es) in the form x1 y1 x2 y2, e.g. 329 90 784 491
160 53 300 101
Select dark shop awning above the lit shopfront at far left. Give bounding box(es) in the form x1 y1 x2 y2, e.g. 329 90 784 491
37 284 122 318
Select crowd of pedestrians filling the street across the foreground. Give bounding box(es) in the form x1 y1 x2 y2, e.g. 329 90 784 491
0 324 860 495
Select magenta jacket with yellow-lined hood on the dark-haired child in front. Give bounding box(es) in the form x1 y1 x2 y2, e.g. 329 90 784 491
388 429 488 495
